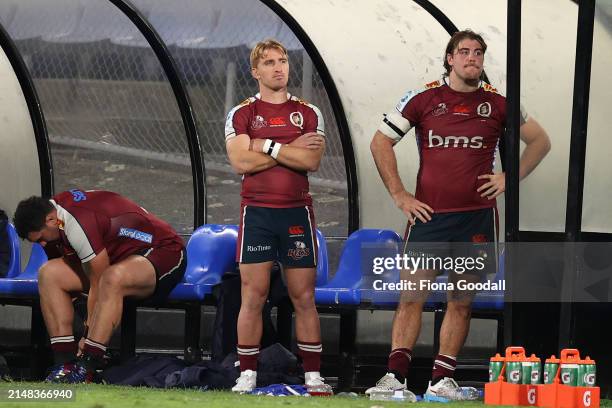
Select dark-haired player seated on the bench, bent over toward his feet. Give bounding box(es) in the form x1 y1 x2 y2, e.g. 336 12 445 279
14 189 186 383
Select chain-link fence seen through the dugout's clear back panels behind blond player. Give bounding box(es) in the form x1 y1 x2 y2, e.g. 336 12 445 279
0 0 347 234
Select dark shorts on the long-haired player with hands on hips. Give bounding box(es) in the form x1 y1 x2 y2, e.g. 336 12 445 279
404 208 498 276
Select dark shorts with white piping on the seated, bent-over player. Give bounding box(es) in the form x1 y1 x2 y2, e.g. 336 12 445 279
138 247 187 303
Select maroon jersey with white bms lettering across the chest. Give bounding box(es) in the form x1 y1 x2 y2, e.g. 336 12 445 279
380 78 526 213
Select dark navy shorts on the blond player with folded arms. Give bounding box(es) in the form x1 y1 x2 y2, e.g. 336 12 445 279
236 205 317 268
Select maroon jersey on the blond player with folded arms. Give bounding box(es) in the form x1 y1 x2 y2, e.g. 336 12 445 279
225 94 325 208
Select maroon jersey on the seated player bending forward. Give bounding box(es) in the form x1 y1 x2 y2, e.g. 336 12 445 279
50 189 183 264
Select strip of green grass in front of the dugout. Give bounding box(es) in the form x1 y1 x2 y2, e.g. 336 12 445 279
0 382 612 408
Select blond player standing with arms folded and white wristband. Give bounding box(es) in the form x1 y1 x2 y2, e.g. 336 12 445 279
225 40 331 392
